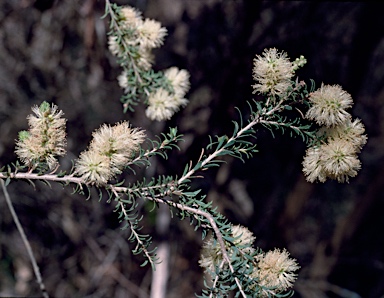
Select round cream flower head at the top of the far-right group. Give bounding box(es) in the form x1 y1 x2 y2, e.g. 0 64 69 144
306 85 353 127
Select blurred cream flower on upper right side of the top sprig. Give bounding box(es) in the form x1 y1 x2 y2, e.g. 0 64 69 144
137 19 167 48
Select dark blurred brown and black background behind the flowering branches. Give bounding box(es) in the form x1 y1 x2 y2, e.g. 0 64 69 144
0 0 384 297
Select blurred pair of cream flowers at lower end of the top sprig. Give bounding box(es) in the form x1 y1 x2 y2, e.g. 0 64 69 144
145 67 190 121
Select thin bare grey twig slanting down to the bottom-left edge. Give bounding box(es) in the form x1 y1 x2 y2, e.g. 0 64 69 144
0 179 49 298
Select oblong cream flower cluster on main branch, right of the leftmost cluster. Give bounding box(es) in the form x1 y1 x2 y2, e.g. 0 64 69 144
75 121 145 185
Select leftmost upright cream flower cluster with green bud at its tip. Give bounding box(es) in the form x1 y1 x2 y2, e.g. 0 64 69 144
15 101 67 170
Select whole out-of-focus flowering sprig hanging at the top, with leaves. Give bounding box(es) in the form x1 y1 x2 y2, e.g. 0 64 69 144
108 6 190 121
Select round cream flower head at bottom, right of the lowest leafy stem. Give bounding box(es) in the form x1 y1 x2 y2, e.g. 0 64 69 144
253 249 300 297
